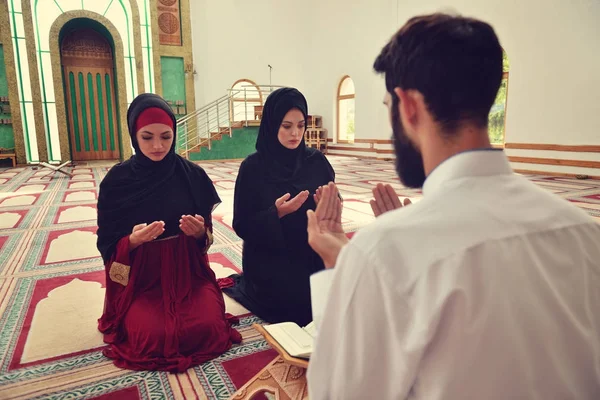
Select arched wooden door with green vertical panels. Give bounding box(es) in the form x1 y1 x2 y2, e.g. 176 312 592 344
61 29 119 161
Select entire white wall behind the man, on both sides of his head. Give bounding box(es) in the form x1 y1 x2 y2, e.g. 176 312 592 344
193 0 600 175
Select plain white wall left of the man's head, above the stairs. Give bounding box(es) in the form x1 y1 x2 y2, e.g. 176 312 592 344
191 0 397 139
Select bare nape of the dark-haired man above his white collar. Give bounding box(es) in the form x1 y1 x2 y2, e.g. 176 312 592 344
421 127 492 175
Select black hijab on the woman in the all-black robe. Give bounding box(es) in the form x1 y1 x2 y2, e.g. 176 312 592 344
256 87 315 183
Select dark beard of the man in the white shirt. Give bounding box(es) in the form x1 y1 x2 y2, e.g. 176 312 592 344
392 98 426 189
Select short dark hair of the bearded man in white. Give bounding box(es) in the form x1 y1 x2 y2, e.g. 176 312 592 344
373 13 502 134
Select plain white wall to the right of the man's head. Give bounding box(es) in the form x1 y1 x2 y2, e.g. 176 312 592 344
408 0 600 176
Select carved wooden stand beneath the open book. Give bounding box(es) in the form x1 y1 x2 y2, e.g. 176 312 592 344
231 324 308 400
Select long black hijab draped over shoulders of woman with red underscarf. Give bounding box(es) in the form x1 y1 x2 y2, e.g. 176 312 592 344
97 93 221 262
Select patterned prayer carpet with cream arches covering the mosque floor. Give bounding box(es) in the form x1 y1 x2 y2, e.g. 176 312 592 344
0 157 600 400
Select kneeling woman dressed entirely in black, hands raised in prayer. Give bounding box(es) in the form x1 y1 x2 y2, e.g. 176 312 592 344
220 88 335 325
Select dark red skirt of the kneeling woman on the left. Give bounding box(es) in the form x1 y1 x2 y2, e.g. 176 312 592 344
98 235 241 372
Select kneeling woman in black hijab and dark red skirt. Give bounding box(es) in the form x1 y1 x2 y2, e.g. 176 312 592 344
98 94 241 372
